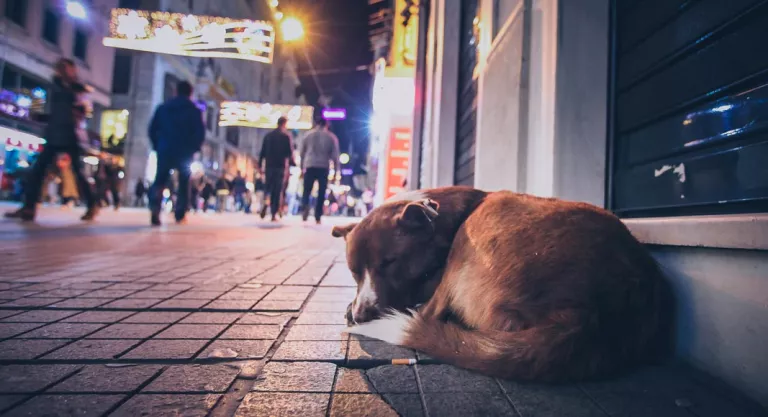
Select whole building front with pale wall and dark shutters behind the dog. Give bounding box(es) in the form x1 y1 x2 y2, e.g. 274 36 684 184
408 0 768 405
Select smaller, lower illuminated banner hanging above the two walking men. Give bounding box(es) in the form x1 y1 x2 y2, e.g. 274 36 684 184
219 101 315 130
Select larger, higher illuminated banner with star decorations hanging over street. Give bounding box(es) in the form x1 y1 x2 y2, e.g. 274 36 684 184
103 9 275 64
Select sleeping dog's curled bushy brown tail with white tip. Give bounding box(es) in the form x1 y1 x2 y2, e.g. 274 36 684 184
346 311 618 382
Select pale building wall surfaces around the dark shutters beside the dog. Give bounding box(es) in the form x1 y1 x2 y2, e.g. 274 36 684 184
416 0 768 406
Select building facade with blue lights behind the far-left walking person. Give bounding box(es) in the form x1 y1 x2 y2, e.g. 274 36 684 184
0 0 117 195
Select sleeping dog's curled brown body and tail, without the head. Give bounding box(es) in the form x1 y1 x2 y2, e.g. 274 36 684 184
344 188 669 381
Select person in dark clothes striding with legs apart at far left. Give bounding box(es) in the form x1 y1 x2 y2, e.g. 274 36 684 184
5 58 98 221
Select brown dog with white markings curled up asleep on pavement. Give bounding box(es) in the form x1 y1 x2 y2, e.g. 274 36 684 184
333 187 671 381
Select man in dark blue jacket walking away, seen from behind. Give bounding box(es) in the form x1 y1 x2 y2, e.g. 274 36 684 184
149 81 205 226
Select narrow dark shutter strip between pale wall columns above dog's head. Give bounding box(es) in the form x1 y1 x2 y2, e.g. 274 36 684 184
453 0 479 186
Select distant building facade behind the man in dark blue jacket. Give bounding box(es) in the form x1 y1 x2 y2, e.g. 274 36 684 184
112 0 304 195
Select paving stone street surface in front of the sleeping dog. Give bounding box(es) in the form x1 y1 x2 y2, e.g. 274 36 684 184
0 210 760 417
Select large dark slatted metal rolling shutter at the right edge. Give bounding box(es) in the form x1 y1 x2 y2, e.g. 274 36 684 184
608 0 768 217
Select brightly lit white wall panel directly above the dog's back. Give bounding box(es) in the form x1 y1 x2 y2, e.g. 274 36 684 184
475 0 558 197
